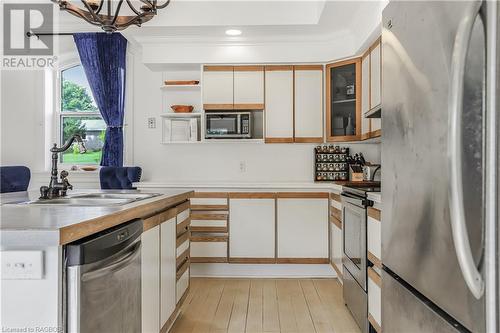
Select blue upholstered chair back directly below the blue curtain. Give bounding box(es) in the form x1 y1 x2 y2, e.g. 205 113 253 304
99 167 142 190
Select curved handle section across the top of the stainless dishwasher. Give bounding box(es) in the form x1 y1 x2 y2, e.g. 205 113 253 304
65 219 143 266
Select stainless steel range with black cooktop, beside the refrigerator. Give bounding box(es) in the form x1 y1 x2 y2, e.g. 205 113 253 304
341 183 380 332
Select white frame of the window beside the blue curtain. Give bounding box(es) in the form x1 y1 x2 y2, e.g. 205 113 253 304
54 61 104 168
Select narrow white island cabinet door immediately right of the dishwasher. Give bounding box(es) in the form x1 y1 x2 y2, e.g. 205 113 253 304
141 225 160 333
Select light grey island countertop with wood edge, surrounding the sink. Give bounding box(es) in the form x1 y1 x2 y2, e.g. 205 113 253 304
0 190 193 247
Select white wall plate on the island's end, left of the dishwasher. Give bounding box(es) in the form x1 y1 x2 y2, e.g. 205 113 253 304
0 251 43 280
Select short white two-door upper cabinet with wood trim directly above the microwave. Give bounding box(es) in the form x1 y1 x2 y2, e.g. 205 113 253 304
203 66 264 110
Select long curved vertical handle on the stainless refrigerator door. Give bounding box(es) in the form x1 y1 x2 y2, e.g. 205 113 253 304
448 1 484 299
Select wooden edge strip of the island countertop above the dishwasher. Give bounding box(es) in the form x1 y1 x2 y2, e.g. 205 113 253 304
59 191 194 245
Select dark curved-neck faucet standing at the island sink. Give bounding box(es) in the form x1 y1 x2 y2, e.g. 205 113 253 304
40 134 87 199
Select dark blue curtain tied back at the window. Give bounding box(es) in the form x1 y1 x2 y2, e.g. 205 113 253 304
73 32 127 166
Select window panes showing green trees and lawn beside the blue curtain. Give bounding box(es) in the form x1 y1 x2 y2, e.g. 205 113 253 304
59 65 106 164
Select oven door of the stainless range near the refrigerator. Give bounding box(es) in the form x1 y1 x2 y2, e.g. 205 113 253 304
342 193 367 291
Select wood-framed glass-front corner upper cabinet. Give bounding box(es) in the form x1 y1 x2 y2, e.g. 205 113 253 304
326 58 362 142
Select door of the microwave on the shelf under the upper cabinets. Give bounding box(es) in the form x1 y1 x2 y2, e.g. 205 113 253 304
206 112 241 138
